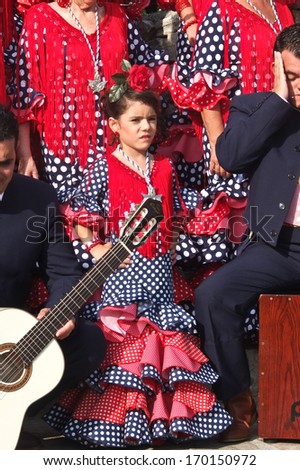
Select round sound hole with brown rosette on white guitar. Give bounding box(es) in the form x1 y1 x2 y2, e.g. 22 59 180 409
0 345 26 387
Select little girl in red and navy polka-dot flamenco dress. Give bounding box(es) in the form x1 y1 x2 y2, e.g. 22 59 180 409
47 66 231 448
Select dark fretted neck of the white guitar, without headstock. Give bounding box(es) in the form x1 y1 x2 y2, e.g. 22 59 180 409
14 241 130 366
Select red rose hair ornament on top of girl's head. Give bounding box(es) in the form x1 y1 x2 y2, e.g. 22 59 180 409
108 59 151 103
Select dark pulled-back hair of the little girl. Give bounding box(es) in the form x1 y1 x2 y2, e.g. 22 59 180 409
101 87 166 141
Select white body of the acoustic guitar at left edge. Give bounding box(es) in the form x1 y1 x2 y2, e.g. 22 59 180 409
0 308 64 450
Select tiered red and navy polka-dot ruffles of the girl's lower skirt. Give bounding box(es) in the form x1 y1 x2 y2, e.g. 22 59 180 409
46 318 232 448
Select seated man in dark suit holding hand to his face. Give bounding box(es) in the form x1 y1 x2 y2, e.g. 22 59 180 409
196 24 300 442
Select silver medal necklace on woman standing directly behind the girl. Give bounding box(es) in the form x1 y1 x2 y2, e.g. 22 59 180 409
67 5 107 93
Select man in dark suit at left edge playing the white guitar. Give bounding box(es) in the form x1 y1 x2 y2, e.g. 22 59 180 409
0 105 106 444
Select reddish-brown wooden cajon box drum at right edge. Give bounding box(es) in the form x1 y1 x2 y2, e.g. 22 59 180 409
258 294 300 440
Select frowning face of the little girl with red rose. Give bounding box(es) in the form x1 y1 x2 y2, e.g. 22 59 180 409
109 100 157 156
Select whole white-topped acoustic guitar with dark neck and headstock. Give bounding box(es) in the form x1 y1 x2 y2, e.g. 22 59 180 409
0 196 163 450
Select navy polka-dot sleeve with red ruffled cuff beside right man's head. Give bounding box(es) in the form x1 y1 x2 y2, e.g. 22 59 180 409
165 1 241 112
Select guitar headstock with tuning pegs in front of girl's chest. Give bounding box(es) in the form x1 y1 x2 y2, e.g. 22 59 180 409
120 196 164 249
